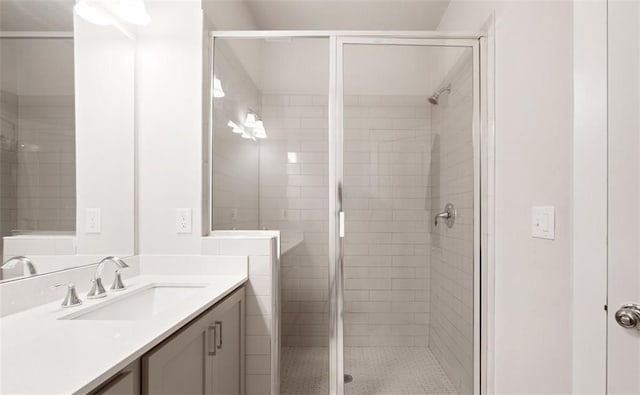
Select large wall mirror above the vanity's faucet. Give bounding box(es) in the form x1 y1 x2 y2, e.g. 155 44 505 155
0 0 135 281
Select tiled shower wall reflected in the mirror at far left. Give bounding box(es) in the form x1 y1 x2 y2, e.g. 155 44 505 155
0 92 76 241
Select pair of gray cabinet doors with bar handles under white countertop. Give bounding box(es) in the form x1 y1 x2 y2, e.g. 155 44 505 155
142 288 245 395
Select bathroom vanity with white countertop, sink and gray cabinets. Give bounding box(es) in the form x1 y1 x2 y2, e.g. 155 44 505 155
0 274 247 394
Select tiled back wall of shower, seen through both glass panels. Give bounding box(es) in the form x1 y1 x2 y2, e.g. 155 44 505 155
260 95 431 347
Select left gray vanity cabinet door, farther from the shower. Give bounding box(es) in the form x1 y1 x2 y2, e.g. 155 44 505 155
142 313 215 395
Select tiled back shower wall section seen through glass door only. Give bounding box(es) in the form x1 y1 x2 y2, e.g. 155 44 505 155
344 95 431 347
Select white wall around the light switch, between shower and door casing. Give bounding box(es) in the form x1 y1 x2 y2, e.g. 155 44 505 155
439 0 573 393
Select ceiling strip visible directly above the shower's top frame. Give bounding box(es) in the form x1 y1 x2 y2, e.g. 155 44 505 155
204 0 449 30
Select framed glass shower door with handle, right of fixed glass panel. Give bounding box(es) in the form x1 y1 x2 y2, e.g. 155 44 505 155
336 39 479 394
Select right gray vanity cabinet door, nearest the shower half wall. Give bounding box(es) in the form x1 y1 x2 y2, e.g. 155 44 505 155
212 290 244 395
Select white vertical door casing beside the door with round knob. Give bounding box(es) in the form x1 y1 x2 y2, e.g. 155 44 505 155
573 0 607 394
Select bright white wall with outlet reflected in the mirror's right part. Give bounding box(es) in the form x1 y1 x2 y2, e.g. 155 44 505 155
74 16 135 255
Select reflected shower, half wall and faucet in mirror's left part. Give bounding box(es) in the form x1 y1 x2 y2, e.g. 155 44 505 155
0 36 76 279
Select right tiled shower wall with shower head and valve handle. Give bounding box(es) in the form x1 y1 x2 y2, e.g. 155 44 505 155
429 53 474 393
